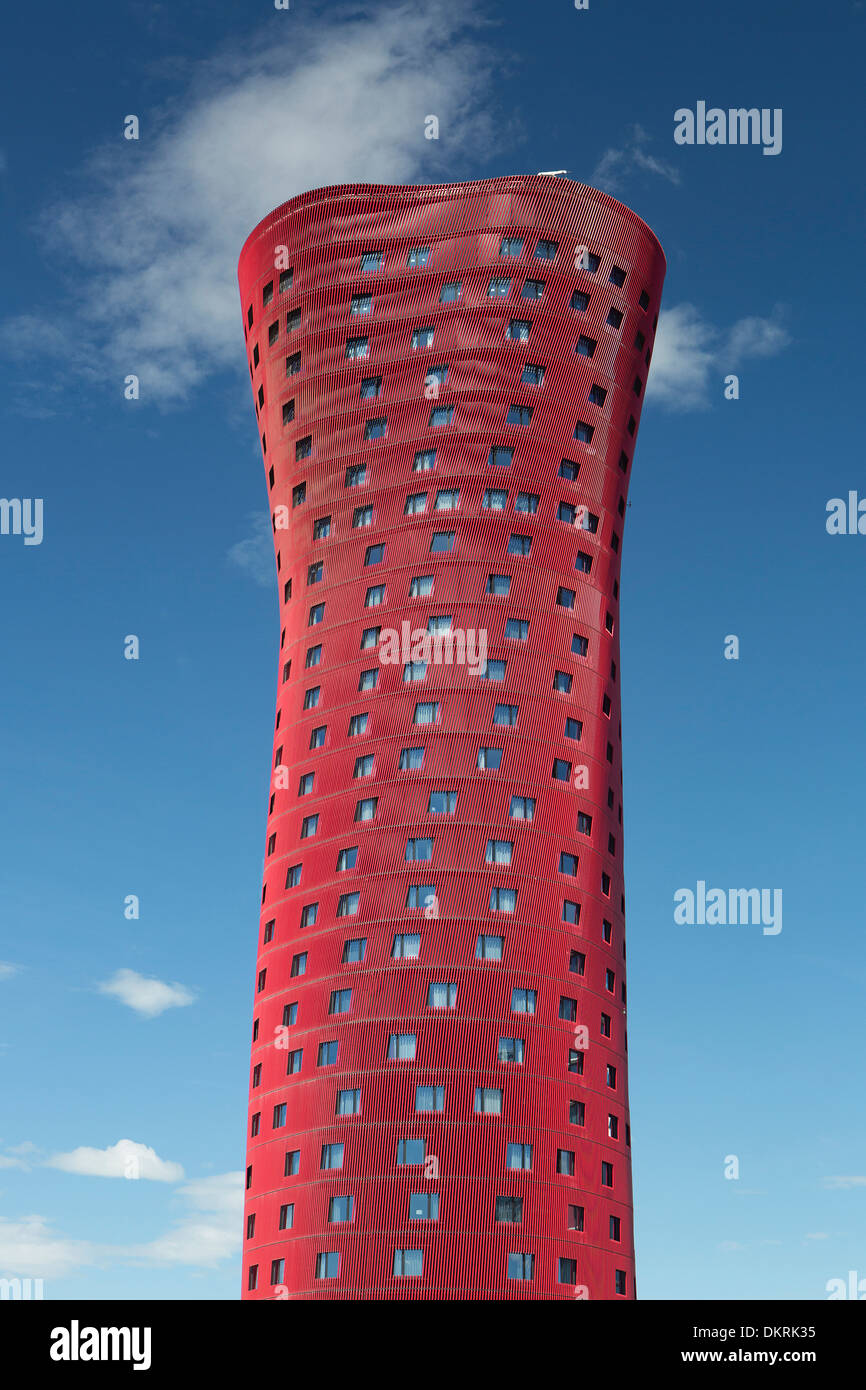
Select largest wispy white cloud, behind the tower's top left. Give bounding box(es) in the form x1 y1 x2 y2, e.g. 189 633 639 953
0 0 505 402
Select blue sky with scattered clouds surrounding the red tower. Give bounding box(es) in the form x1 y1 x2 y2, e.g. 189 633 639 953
0 0 866 1298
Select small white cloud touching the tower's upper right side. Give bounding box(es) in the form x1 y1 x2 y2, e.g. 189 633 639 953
646 303 791 410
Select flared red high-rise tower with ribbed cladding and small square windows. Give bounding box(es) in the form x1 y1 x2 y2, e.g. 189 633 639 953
239 175 664 1300
